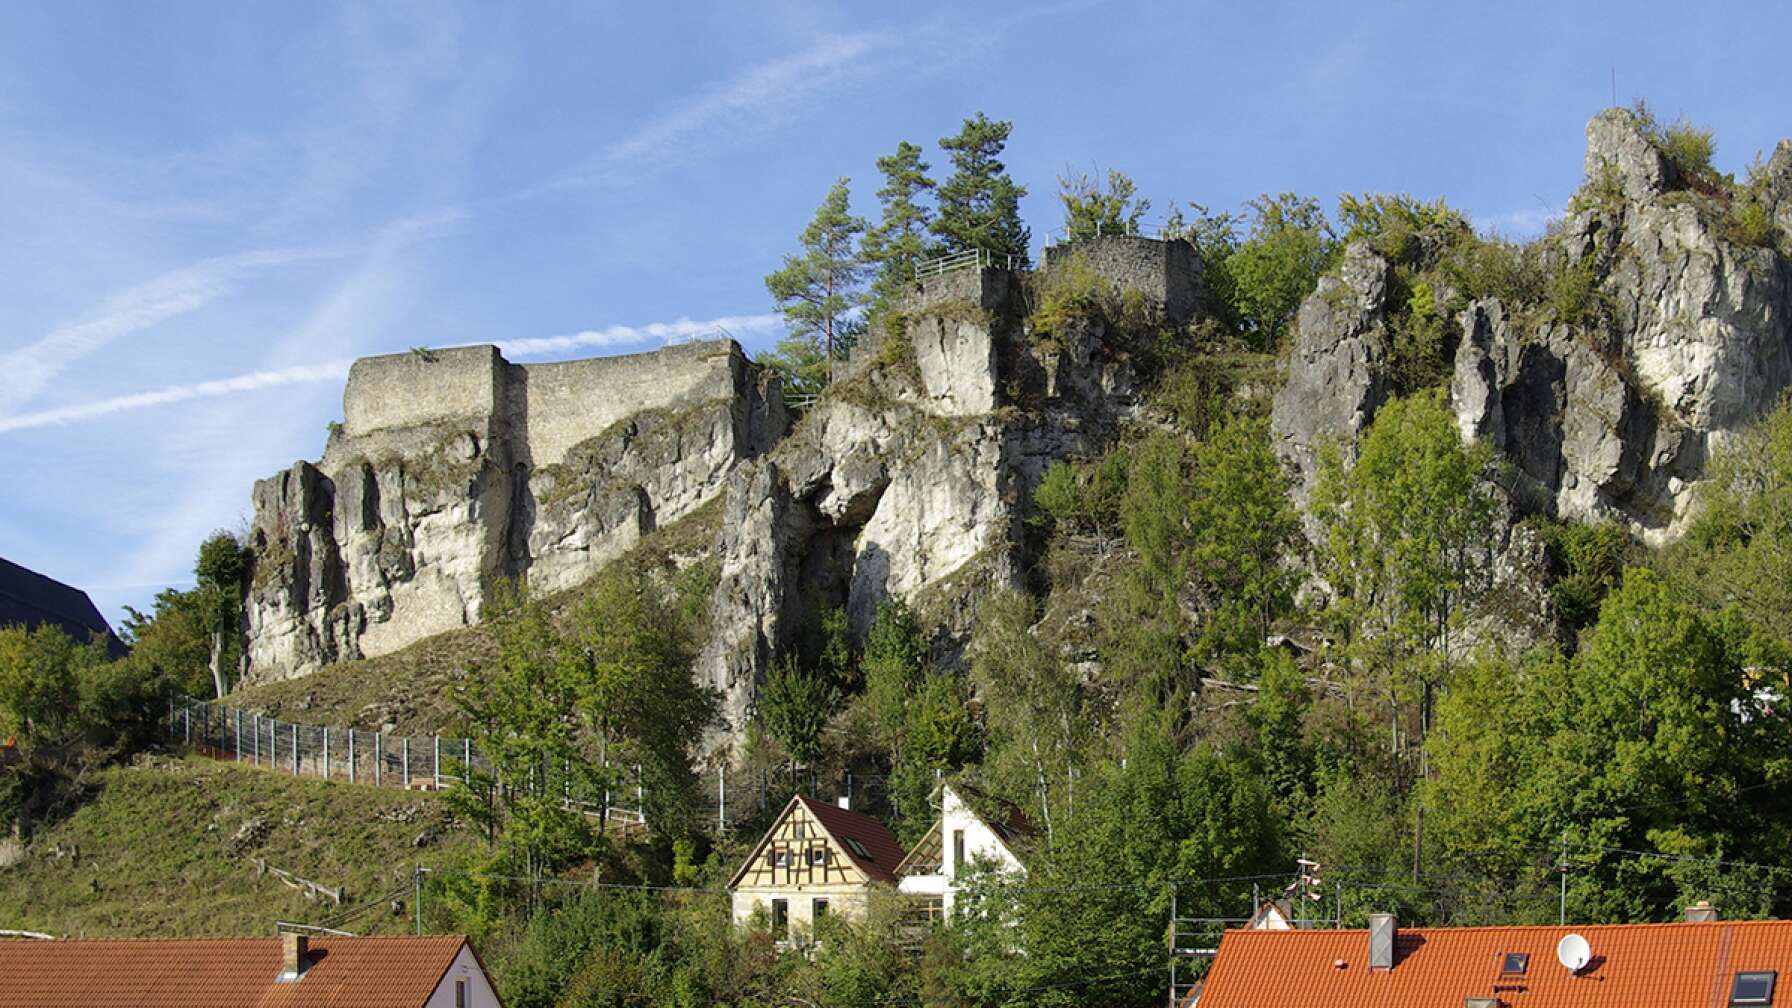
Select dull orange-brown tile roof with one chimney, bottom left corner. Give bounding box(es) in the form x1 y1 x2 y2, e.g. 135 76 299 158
0 934 466 1008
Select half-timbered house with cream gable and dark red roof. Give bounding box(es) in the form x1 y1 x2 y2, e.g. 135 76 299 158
728 795 903 942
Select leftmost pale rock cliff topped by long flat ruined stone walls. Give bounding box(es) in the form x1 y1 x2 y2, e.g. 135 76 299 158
246 341 787 680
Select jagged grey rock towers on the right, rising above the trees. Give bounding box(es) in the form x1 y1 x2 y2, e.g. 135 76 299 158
1272 109 1792 542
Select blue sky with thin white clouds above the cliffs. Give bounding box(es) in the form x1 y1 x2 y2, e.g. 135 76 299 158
0 0 1792 622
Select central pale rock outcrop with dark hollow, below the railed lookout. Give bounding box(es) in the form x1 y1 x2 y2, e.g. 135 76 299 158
699 269 1161 728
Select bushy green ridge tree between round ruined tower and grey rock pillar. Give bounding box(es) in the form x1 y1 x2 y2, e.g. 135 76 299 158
1226 192 1337 352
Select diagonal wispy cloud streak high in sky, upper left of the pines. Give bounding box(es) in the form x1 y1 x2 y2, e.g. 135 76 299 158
534 32 894 197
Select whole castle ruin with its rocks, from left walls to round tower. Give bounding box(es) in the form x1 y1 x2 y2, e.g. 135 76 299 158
234 237 1199 726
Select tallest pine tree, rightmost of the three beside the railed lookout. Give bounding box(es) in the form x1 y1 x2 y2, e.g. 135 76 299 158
932 113 1032 256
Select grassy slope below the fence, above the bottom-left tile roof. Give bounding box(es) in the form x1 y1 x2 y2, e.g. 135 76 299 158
0 757 478 936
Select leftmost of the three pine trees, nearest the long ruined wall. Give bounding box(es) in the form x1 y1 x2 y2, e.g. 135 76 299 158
765 178 866 391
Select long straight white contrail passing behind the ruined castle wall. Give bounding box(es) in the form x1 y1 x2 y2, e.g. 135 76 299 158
0 314 781 434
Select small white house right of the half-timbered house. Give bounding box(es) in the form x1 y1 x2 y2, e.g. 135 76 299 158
896 784 1032 918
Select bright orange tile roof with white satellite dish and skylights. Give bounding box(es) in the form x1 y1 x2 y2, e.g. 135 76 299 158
1201 920 1792 1008
